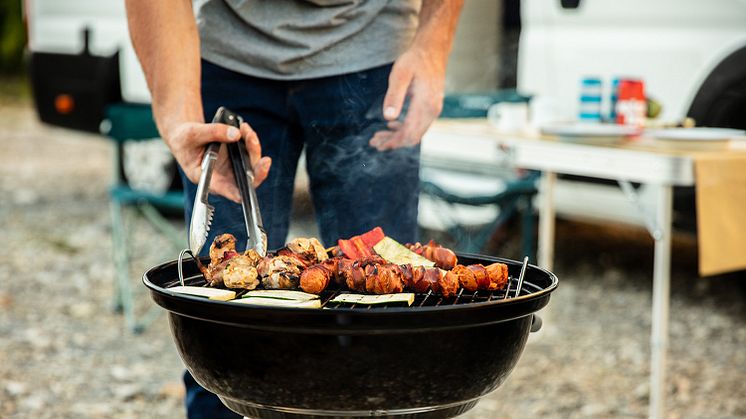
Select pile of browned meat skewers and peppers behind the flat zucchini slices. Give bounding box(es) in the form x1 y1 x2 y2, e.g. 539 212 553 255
203 228 508 297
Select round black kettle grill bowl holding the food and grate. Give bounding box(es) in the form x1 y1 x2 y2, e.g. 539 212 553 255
143 254 557 418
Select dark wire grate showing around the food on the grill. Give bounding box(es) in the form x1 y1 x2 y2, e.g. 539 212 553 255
166 274 543 310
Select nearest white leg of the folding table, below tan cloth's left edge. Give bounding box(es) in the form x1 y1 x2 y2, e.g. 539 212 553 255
649 185 673 419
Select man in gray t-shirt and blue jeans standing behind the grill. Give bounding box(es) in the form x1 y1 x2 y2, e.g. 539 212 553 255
126 0 462 417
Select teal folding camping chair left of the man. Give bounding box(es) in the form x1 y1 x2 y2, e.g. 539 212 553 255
101 104 186 333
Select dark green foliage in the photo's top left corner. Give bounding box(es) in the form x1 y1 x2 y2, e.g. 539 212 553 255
0 0 26 73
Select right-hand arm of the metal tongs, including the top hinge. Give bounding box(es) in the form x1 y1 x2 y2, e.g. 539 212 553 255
216 107 267 256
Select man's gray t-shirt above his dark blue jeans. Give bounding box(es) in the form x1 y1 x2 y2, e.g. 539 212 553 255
194 0 420 80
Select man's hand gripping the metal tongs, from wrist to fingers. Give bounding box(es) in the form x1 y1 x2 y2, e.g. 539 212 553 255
166 122 272 202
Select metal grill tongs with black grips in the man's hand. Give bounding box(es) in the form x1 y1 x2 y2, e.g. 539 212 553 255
178 106 267 285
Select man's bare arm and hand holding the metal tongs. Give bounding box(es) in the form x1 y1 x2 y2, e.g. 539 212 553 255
126 0 271 201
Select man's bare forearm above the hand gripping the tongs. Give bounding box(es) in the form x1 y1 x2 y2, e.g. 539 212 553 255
126 0 203 141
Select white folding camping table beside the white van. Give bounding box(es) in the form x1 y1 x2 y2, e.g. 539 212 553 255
428 119 744 418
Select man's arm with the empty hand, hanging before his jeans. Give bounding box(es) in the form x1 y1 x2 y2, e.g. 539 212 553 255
370 0 463 150
